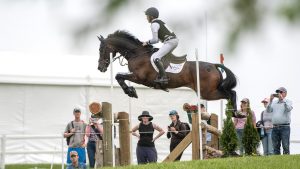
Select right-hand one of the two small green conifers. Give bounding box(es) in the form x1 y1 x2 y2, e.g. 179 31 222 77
242 113 259 155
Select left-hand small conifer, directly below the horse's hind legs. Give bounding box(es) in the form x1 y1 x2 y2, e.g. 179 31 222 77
220 101 238 156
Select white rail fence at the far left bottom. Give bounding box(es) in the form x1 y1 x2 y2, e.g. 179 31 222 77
0 135 66 169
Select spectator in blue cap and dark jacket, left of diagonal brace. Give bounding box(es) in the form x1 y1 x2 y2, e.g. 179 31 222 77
167 110 187 161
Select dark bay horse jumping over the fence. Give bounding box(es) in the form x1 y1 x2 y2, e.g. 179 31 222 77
98 31 237 110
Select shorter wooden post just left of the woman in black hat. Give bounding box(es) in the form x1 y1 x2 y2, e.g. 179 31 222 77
118 112 131 166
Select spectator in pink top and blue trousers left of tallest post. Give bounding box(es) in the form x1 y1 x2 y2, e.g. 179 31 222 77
86 115 103 168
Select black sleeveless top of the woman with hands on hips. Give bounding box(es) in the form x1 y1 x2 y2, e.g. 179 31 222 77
138 122 154 147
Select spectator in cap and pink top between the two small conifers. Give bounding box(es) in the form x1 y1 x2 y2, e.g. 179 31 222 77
233 98 256 155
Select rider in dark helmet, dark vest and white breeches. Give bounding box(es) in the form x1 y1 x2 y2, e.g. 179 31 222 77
143 7 178 84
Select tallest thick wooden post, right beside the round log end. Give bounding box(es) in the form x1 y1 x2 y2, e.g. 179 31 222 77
102 102 113 167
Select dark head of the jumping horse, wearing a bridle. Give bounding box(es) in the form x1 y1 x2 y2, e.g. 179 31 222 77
98 35 115 72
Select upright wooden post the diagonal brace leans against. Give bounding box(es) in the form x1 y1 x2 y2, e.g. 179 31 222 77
191 113 200 160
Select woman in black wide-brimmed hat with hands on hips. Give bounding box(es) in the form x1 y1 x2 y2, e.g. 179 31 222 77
132 111 165 164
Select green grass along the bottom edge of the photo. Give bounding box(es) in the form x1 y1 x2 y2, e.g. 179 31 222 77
6 155 300 169
